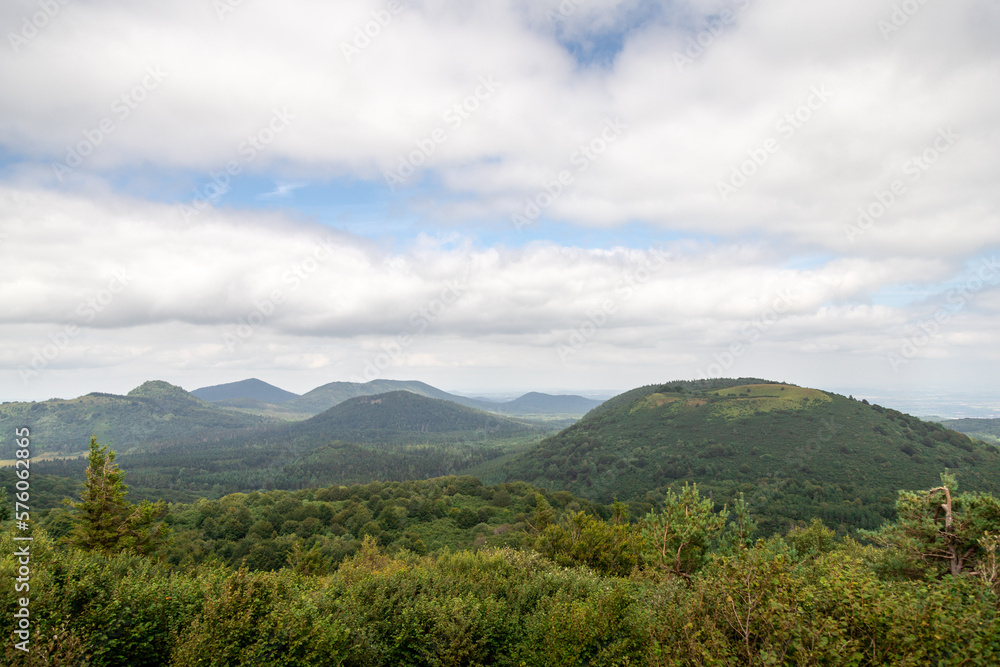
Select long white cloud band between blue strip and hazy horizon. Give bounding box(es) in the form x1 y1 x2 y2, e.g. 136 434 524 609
0 183 996 402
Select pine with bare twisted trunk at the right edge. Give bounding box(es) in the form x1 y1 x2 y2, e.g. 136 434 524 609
868 473 1000 576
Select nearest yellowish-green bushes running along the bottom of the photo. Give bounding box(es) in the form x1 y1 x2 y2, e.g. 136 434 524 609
0 520 1000 667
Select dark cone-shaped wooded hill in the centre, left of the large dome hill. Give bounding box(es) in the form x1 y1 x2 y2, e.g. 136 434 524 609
293 391 542 442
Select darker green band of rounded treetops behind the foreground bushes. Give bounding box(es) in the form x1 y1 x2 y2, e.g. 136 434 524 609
158 476 611 574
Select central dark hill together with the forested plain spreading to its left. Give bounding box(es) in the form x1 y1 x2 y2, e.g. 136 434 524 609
86 391 555 501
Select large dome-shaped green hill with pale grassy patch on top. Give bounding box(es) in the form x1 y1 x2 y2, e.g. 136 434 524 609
505 378 1000 527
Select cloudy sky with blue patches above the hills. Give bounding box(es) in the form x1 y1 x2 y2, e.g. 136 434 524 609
0 0 1000 412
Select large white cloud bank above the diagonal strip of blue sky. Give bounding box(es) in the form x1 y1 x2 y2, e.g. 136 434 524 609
0 0 1000 255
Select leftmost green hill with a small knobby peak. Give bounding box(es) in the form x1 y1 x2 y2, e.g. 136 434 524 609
0 381 266 454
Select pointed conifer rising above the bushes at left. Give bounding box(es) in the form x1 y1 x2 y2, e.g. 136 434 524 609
66 437 166 554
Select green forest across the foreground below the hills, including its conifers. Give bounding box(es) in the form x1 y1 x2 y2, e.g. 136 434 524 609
0 440 1000 666
